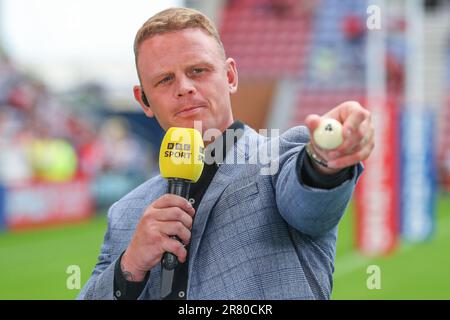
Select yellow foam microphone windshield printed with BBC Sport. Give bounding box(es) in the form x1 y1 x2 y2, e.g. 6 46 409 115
159 127 205 182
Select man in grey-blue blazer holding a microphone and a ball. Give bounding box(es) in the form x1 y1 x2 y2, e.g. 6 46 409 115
79 8 374 299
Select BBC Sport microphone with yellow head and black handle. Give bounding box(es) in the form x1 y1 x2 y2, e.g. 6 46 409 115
159 127 205 298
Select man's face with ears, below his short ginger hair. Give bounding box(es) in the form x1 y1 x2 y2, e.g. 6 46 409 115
134 28 237 131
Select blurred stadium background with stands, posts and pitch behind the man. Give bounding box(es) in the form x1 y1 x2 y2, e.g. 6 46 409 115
0 0 450 299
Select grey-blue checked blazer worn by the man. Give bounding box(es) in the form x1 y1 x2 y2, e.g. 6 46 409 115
78 126 362 299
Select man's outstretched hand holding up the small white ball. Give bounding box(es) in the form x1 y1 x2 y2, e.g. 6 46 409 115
305 101 375 174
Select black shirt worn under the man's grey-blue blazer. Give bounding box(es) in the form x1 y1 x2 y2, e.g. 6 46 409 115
114 121 353 300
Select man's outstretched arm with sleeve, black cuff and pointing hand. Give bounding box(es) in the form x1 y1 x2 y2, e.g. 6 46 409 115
275 102 374 236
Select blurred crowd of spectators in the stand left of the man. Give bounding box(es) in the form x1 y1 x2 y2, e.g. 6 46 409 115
0 53 155 208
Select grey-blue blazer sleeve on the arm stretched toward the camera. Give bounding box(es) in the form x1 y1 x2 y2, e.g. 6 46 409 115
273 127 363 237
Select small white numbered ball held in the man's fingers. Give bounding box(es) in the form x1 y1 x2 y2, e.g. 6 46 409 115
313 118 343 150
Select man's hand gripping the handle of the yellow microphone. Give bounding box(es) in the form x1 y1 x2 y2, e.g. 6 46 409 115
121 194 195 281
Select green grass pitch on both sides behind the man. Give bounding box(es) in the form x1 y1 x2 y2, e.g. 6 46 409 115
0 196 450 299
